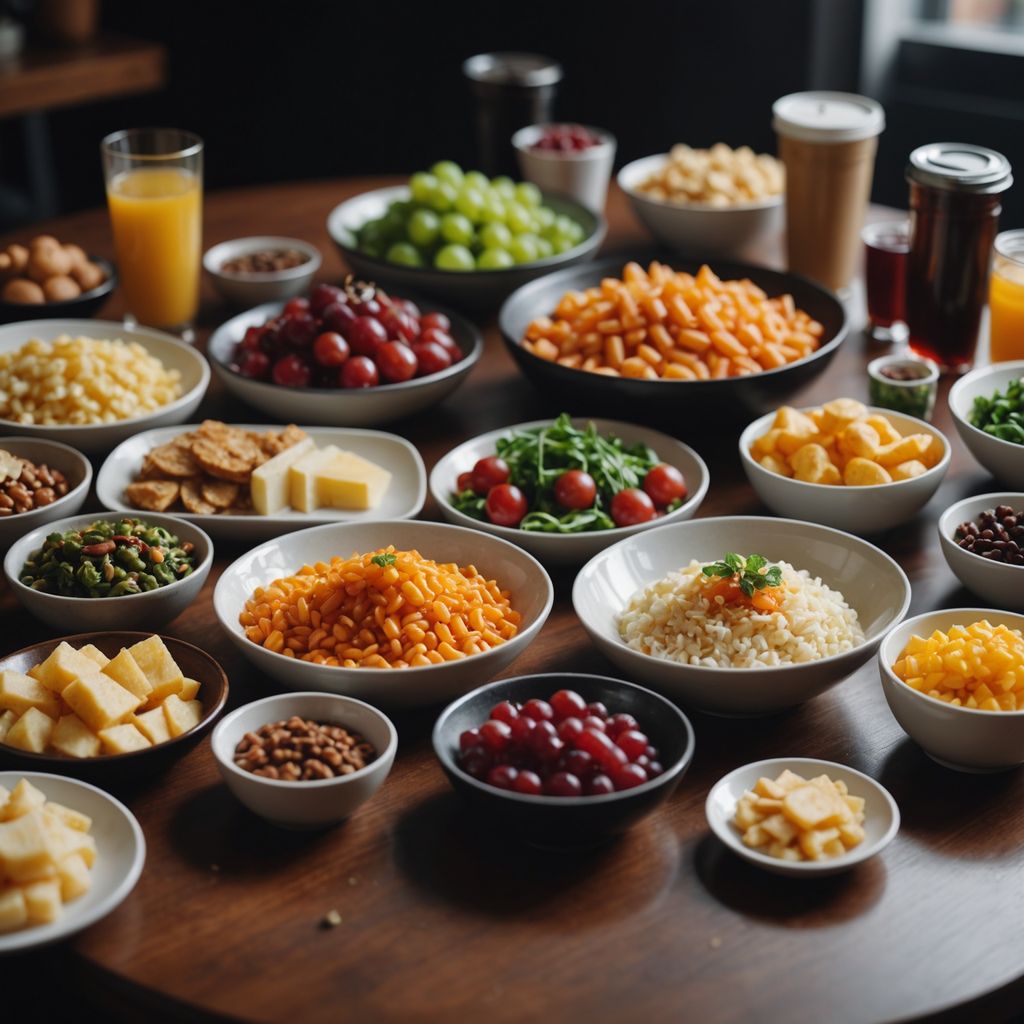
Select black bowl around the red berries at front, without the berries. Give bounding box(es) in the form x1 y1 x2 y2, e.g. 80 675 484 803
433 672 694 848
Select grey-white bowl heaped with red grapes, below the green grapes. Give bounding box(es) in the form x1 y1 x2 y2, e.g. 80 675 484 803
207 279 483 427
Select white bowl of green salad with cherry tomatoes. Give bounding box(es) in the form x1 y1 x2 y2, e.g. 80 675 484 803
430 413 710 565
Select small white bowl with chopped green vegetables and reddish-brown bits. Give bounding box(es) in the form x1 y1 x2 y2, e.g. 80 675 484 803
3 512 213 633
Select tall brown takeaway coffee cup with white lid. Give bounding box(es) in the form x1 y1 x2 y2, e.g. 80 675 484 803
772 92 886 292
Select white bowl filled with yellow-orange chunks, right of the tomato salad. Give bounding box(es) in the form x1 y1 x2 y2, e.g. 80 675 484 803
739 398 951 535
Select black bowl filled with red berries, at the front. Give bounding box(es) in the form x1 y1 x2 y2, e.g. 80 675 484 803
433 673 694 848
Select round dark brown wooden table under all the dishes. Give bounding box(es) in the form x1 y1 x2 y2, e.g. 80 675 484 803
0 180 1024 1022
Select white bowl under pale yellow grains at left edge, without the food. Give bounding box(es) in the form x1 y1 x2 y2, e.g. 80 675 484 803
0 319 210 455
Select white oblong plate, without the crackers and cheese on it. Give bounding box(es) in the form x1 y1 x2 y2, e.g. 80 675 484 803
96 423 427 541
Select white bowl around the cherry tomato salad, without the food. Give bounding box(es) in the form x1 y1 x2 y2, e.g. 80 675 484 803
430 417 711 565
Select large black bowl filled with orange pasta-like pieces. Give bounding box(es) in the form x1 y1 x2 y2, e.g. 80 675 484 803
499 257 847 421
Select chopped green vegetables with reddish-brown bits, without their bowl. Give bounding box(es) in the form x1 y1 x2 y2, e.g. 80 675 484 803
18 517 196 597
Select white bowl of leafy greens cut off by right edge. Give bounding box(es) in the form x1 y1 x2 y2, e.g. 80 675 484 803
949 359 1024 490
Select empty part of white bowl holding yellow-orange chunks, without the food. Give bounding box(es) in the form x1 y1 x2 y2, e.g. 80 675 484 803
739 407 951 535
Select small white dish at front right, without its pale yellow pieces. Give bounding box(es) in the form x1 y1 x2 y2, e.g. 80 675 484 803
705 758 899 879
